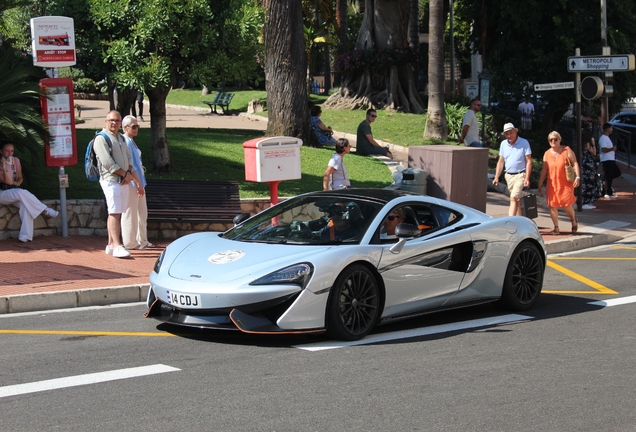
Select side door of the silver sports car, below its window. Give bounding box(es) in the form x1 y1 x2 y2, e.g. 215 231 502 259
378 204 472 317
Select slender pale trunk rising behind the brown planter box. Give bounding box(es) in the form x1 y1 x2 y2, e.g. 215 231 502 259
424 0 448 140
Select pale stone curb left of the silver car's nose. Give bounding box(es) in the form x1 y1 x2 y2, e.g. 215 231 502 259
0 284 150 315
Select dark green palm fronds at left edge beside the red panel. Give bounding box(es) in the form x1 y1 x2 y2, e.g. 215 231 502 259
0 46 47 155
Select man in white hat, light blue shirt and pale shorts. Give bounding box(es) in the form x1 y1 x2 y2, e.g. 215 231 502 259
492 123 532 216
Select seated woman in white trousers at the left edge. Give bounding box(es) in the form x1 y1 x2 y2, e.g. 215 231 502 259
0 143 58 242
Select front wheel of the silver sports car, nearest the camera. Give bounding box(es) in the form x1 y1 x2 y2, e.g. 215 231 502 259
327 265 380 340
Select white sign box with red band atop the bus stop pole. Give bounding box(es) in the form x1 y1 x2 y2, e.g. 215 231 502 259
31 16 75 67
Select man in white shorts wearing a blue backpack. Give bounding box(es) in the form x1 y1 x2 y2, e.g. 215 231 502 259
93 111 133 258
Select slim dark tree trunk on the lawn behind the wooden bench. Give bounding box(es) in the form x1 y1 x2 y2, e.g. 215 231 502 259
146 87 172 173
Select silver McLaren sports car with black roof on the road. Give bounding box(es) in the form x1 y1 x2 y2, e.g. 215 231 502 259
146 189 546 340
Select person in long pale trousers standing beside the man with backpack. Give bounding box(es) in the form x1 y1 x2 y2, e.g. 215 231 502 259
121 115 153 250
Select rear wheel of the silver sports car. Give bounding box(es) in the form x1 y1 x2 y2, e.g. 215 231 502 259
497 242 544 311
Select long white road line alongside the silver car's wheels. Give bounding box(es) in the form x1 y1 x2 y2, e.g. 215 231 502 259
294 314 534 351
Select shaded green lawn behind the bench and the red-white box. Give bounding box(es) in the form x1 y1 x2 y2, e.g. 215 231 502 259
23 128 393 199
